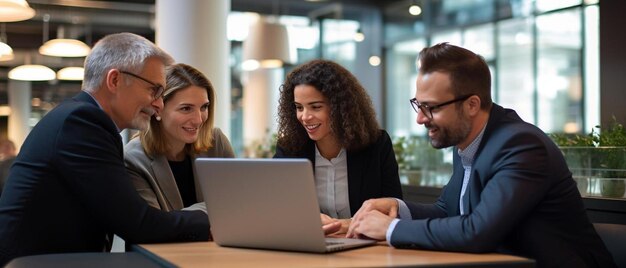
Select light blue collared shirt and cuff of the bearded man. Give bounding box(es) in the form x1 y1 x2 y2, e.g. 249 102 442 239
385 124 487 245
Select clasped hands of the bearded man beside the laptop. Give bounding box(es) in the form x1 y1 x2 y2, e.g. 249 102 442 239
346 198 398 240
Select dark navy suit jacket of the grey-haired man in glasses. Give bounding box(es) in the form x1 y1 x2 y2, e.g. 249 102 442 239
0 92 209 266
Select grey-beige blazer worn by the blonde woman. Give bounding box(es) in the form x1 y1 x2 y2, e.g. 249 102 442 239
124 128 235 211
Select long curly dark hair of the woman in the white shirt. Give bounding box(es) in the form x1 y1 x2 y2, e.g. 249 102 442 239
277 60 380 152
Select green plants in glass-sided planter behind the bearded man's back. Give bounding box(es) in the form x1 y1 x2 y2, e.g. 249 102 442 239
551 119 626 198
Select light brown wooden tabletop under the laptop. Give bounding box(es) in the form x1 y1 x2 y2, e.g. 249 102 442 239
132 242 535 267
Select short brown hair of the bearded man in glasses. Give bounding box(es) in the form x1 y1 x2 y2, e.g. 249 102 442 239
419 43 492 110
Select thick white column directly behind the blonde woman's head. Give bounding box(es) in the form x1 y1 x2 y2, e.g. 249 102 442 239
155 0 230 136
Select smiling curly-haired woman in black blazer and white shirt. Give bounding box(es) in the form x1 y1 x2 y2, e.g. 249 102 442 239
274 60 402 232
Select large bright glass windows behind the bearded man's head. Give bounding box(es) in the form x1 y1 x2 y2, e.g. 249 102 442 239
384 0 600 188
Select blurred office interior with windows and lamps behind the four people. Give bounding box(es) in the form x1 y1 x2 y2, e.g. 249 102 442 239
0 0 626 156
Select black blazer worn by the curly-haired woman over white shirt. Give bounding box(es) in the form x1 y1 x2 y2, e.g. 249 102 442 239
274 130 402 215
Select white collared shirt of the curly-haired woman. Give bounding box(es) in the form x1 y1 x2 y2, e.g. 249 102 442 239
315 146 351 219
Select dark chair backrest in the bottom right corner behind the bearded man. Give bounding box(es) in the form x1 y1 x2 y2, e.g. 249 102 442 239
593 223 626 268
